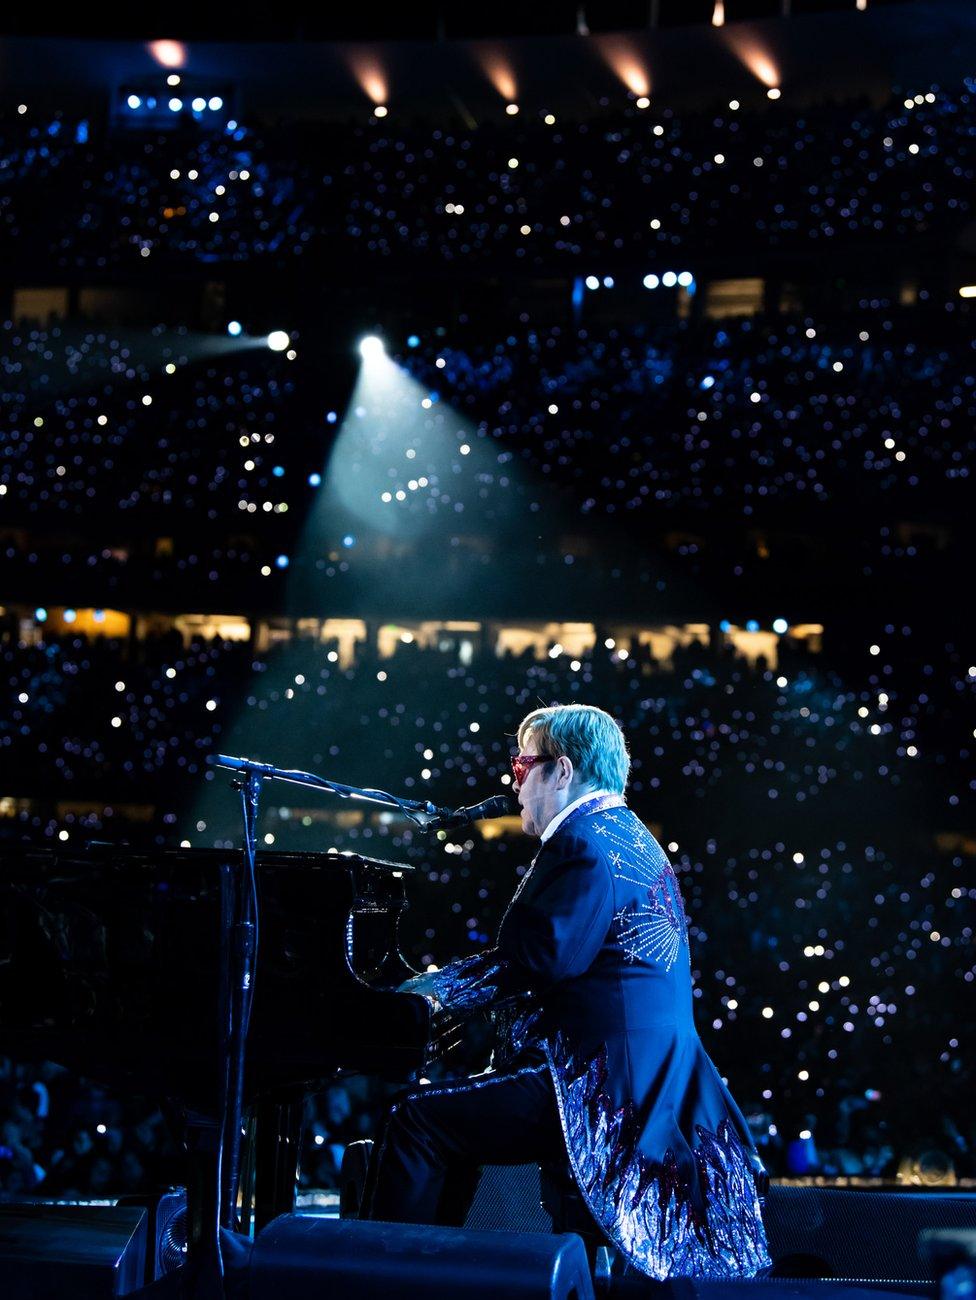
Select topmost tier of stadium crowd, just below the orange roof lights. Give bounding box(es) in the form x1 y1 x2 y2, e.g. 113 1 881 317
0 81 973 274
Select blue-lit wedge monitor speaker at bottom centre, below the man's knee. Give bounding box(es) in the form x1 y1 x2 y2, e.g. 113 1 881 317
250 1214 593 1300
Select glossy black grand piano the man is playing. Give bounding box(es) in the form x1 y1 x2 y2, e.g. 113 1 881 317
0 845 438 1279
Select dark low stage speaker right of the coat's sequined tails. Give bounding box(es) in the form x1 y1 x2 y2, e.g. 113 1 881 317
765 1183 976 1282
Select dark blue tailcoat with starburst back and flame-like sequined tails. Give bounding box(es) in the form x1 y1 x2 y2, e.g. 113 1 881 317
426 797 769 1278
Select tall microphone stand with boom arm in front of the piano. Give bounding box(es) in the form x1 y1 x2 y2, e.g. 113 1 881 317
207 754 441 1232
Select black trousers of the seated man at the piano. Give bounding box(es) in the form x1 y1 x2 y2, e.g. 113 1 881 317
360 1062 565 1227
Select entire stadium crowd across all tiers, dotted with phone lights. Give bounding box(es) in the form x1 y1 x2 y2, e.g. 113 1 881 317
0 65 976 1199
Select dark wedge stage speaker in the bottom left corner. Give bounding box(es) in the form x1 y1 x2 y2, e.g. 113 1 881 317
0 1201 146 1300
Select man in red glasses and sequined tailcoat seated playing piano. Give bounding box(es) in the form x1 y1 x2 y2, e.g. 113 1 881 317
361 705 769 1279
